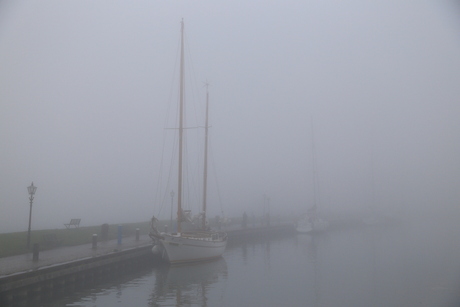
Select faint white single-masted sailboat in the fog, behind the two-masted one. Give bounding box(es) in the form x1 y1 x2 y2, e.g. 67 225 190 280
296 120 329 233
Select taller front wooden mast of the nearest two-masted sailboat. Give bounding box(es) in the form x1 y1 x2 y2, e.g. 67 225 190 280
177 19 184 233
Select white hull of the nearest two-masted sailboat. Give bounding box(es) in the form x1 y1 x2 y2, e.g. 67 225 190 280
155 232 227 264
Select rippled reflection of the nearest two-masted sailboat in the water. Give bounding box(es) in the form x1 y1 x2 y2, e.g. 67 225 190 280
149 258 228 307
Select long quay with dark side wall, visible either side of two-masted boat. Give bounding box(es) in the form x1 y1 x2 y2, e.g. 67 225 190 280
0 223 295 307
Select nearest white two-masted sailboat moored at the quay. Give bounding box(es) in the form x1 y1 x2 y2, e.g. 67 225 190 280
150 20 227 264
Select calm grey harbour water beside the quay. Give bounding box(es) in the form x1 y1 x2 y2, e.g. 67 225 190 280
41 221 460 307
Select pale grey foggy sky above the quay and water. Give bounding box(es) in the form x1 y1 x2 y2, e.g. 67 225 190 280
0 0 460 232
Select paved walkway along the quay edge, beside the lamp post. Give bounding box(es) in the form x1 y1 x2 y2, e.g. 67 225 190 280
0 235 152 278
